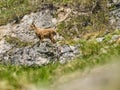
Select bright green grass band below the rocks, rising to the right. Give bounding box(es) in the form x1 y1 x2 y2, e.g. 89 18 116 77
0 31 120 90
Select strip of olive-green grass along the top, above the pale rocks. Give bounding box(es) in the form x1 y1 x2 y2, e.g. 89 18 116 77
0 0 107 25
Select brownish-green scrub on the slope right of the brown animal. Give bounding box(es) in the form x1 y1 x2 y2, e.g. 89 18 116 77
57 0 112 40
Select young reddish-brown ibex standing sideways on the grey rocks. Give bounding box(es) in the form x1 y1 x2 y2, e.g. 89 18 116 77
31 23 57 43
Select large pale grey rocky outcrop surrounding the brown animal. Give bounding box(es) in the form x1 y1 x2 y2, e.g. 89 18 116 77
0 5 80 66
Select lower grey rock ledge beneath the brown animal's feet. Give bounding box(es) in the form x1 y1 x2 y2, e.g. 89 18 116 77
0 38 79 66
